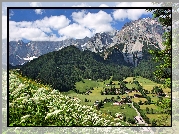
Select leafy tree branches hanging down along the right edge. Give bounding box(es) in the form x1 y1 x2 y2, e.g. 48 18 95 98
147 8 172 88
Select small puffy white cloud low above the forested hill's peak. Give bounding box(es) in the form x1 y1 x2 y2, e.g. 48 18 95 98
59 23 92 39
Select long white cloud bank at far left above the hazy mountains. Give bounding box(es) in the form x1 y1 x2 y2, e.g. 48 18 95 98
8 15 70 41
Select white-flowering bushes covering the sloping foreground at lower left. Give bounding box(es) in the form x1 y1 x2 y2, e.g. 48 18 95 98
9 71 127 126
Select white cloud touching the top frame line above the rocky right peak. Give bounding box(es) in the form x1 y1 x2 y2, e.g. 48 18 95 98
113 9 151 21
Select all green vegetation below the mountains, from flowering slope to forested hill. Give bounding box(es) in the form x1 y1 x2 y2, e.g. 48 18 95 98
10 7 171 126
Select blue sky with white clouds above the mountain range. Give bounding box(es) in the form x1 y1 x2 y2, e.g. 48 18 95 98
2 2 161 41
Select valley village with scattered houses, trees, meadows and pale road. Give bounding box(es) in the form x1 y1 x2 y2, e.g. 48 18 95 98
69 78 171 126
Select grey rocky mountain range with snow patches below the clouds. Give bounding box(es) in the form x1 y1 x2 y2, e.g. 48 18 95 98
9 18 164 66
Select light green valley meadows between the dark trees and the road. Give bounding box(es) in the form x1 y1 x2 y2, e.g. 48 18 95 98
62 77 171 126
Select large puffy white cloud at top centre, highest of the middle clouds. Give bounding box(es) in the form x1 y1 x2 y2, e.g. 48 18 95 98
72 10 113 33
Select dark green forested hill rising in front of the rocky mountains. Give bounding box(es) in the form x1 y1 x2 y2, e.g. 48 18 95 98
20 46 136 91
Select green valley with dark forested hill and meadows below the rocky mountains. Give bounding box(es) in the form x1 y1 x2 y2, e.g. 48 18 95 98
10 46 171 126
